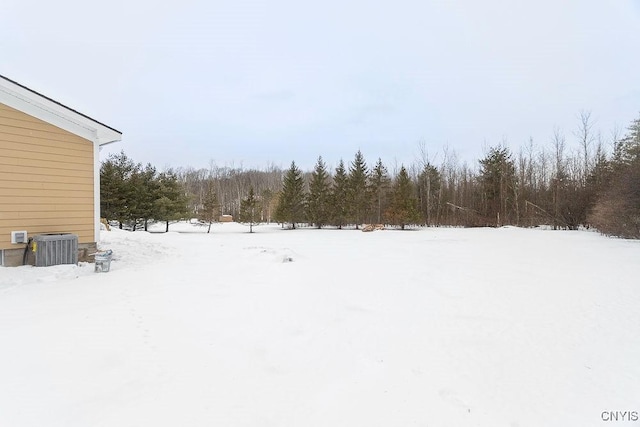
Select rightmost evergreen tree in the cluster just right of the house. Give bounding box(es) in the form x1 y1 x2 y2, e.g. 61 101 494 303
154 170 189 232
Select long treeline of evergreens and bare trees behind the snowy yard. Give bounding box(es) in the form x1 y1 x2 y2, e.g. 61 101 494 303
101 113 640 238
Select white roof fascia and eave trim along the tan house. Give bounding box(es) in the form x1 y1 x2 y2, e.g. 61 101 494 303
0 77 122 145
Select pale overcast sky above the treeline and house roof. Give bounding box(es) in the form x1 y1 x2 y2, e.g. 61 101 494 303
0 0 640 169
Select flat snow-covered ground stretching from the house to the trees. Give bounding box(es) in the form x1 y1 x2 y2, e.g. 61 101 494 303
0 224 640 427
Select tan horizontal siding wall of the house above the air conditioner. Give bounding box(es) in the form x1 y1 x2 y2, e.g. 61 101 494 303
0 104 94 249
